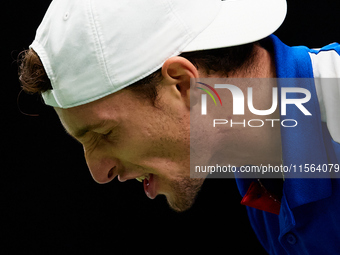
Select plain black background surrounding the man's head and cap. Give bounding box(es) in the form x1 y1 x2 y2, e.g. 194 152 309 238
0 0 340 254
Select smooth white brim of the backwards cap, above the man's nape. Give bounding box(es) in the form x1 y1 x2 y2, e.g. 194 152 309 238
183 0 287 52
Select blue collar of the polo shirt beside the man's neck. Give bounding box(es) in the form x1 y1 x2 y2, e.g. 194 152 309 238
268 35 332 209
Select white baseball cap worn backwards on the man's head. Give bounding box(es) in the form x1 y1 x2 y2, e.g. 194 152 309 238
30 0 287 108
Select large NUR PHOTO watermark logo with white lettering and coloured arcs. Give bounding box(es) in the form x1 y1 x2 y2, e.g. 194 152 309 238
194 78 312 128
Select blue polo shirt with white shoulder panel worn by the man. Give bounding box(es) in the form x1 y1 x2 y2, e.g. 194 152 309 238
236 35 340 255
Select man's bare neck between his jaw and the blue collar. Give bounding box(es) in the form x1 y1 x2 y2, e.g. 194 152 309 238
212 46 282 166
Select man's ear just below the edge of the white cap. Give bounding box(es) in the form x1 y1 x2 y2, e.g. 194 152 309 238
162 56 199 107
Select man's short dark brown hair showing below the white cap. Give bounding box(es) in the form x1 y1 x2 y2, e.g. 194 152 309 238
18 43 254 106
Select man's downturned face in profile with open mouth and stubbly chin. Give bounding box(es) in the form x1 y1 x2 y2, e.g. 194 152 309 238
55 83 203 211
